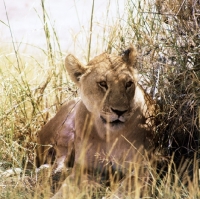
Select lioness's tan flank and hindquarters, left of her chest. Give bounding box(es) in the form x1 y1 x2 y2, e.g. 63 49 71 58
36 100 77 169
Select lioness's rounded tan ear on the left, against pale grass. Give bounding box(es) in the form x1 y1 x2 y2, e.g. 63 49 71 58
65 54 86 84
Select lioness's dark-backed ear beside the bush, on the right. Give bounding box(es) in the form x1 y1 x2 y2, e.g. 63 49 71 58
122 46 137 67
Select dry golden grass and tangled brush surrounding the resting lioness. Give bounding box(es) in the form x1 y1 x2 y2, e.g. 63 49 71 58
0 0 200 199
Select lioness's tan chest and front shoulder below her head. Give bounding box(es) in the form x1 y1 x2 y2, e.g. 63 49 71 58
75 104 147 175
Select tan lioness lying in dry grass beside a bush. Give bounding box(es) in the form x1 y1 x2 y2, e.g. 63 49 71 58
38 47 155 197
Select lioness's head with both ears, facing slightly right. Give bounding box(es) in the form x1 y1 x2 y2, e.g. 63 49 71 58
65 47 152 135
